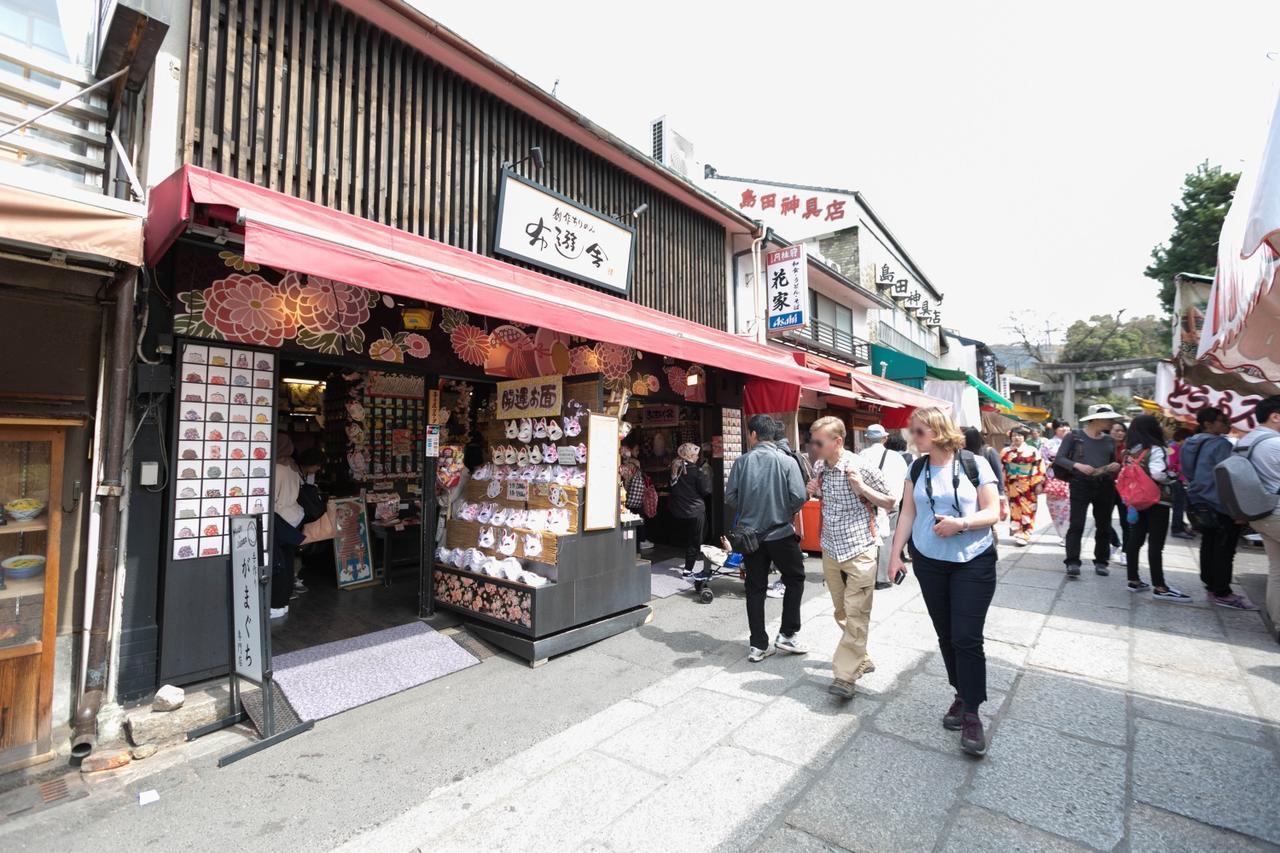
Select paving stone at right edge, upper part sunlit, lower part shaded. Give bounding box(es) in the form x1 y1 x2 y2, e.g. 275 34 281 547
1132 665 1270 740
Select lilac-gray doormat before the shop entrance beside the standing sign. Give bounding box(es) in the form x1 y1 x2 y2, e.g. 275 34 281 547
273 622 480 720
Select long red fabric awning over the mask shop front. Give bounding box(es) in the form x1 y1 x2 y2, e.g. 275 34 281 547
146 167 828 391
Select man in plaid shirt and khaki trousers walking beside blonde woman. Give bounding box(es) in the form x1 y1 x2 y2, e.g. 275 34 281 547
809 418 897 699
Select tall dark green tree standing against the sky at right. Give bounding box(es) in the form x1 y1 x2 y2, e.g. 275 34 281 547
1143 160 1240 314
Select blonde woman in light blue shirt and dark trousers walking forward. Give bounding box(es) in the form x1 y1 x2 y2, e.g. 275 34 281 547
888 409 1000 756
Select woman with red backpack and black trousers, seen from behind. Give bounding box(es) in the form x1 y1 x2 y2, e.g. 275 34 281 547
1116 415 1190 602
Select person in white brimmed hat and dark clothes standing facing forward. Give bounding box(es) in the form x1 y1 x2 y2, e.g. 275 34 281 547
1053 403 1120 578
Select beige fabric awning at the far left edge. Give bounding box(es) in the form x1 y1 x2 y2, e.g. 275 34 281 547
0 162 143 266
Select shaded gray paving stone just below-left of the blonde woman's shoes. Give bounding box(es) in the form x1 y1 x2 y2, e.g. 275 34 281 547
783 733 972 850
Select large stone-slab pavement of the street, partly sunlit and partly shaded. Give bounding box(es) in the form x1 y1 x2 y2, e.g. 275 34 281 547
342 512 1280 853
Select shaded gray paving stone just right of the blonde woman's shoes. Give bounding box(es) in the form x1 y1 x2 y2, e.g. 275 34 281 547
968 720 1126 849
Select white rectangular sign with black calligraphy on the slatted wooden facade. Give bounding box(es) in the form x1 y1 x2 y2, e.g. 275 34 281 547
494 169 636 295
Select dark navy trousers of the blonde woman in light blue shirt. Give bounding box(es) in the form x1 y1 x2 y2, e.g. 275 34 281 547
911 544 997 712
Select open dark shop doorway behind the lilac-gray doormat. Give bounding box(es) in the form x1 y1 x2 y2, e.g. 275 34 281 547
271 357 426 657
